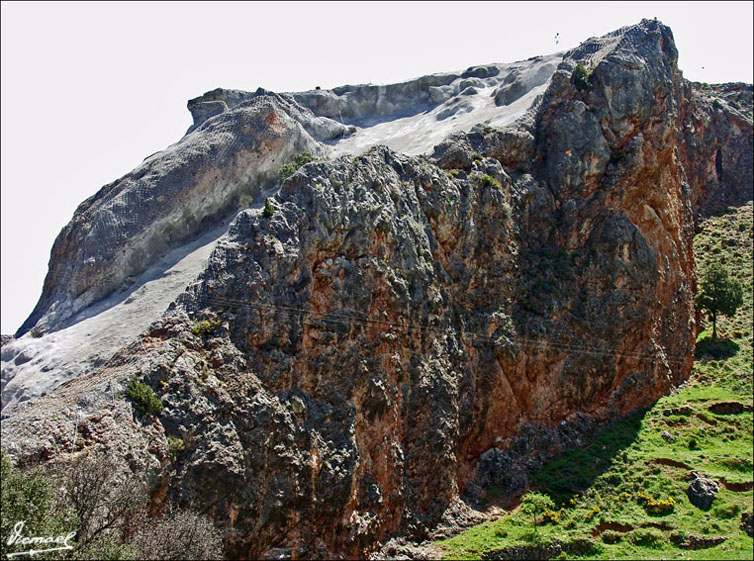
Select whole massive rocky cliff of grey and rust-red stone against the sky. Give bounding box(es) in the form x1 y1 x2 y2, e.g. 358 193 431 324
2 20 752 558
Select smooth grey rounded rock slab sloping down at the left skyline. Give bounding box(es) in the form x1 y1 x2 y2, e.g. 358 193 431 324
17 94 318 336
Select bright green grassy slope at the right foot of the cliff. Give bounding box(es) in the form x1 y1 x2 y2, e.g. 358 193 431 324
434 203 753 559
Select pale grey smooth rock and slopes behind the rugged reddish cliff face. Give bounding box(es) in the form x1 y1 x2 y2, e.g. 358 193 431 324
2 51 562 406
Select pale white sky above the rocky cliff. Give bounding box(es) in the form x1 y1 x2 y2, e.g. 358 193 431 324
0 2 754 333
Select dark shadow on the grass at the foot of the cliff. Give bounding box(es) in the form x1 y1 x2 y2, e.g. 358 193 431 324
531 410 646 504
